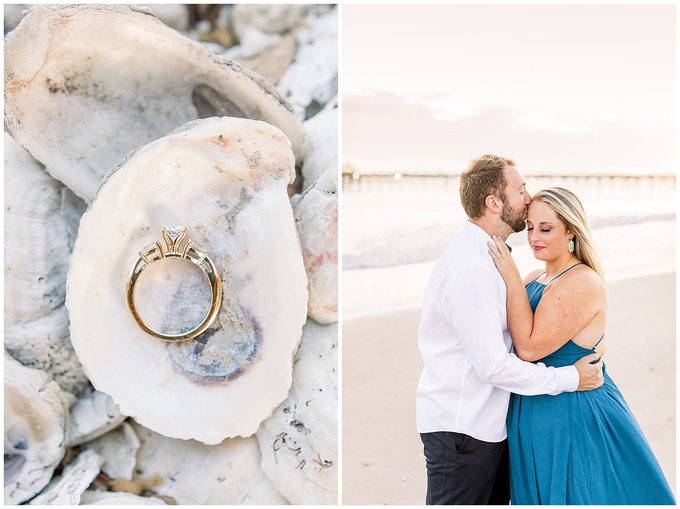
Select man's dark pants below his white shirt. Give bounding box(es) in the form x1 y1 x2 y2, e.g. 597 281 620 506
420 431 510 505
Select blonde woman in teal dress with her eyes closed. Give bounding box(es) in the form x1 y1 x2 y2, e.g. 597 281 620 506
489 187 675 504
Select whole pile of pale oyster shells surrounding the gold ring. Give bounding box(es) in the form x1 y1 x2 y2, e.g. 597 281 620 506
4 4 338 505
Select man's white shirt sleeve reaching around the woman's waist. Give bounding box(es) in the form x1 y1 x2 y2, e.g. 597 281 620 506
443 265 579 396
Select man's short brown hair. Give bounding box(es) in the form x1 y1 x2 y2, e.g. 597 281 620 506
460 154 515 219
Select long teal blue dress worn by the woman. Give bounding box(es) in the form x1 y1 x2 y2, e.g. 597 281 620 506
507 267 675 505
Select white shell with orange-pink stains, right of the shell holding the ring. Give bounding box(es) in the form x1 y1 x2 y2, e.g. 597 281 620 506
291 167 338 324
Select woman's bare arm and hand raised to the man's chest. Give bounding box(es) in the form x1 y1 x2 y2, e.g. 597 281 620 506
489 238 606 361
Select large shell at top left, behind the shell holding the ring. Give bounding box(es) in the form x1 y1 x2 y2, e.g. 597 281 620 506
5 4 308 201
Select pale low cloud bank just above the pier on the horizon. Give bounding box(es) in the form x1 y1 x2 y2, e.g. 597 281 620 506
342 92 675 174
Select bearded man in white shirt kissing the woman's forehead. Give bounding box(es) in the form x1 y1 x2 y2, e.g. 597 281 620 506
416 155 604 504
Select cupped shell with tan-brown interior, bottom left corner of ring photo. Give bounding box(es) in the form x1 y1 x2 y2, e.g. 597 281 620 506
5 352 68 504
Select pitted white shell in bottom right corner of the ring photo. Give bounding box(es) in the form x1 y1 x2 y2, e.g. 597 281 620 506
256 320 339 505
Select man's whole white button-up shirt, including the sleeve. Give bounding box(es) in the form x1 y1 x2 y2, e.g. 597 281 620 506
416 221 579 442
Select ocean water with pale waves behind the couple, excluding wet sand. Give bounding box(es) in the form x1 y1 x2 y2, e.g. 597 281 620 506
342 176 675 270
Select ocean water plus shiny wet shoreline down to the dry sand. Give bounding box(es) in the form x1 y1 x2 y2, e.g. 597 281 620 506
341 176 676 318
